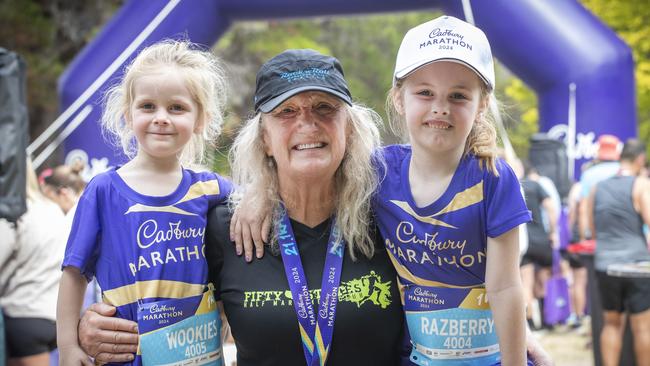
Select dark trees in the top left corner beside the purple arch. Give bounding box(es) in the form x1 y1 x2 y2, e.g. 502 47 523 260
0 0 121 164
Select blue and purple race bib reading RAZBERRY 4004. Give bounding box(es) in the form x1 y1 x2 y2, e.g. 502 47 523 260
404 285 501 366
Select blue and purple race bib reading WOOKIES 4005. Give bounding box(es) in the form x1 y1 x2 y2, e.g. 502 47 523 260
138 289 223 365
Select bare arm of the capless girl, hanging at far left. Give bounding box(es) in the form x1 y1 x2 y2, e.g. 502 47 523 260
56 267 93 366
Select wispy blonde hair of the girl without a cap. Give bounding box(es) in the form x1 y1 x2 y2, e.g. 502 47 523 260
102 40 226 165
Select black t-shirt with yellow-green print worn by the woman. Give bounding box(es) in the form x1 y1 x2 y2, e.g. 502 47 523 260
206 206 404 366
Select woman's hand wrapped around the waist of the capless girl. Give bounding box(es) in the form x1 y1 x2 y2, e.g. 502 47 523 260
79 303 138 363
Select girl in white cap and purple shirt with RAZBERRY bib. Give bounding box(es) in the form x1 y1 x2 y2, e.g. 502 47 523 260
373 16 530 365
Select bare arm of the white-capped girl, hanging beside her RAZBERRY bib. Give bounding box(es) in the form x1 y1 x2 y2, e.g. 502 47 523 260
485 227 526 366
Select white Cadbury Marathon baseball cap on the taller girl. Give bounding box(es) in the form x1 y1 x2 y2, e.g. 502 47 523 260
393 15 494 90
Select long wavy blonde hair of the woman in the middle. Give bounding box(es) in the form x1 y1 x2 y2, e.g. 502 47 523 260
230 104 381 260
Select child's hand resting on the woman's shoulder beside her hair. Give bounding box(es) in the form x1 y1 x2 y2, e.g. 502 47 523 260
230 199 271 262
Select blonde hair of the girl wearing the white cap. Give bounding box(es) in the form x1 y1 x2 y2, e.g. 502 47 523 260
386 76 498 176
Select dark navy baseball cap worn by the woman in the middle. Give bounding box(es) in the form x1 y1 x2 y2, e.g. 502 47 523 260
254 49 352 113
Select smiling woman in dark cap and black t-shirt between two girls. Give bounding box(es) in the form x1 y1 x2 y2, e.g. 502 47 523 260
79 50 550 365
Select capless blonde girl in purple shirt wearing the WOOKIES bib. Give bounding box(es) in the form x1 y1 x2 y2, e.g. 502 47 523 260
57 41 232 365
